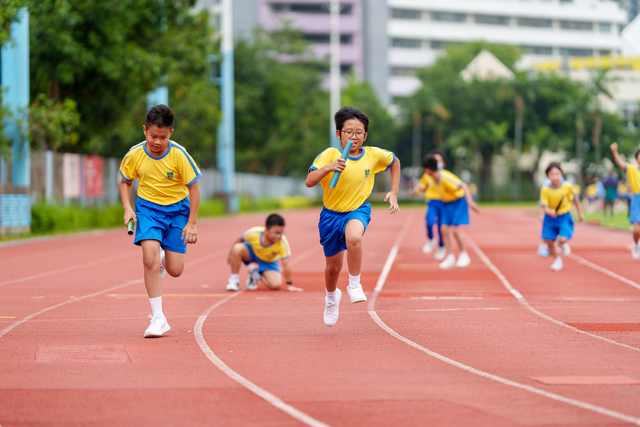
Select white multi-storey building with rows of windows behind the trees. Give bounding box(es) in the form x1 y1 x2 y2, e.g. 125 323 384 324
387 0 628 97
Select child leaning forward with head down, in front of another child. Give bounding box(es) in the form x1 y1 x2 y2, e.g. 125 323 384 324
423 154 480 269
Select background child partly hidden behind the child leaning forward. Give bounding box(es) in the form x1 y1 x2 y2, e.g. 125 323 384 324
416 150 447 261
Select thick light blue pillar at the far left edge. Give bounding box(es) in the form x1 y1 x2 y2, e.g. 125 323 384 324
2 7 31 187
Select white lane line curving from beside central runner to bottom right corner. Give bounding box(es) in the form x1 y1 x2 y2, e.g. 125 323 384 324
367 212 640 425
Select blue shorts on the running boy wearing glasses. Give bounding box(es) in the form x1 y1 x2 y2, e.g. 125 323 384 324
318 202 371 257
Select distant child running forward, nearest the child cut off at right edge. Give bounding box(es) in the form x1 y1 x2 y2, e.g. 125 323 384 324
540 162 584 271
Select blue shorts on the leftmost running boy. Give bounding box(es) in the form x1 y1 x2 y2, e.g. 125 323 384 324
133 197 190 254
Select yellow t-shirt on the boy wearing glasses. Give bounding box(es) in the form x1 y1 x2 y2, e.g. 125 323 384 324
309 147 396 212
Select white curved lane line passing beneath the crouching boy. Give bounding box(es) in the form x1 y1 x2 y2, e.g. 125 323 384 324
193 245 329 427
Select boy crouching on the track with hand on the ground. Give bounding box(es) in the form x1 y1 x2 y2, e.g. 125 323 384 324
227 214 302 291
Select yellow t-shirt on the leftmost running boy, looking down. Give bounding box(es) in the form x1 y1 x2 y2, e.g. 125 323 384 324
120 141 202 206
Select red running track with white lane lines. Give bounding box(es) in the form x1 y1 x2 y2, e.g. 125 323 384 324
0 209 640 427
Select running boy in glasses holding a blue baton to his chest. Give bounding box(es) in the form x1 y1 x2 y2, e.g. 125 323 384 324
306 106 400 326
